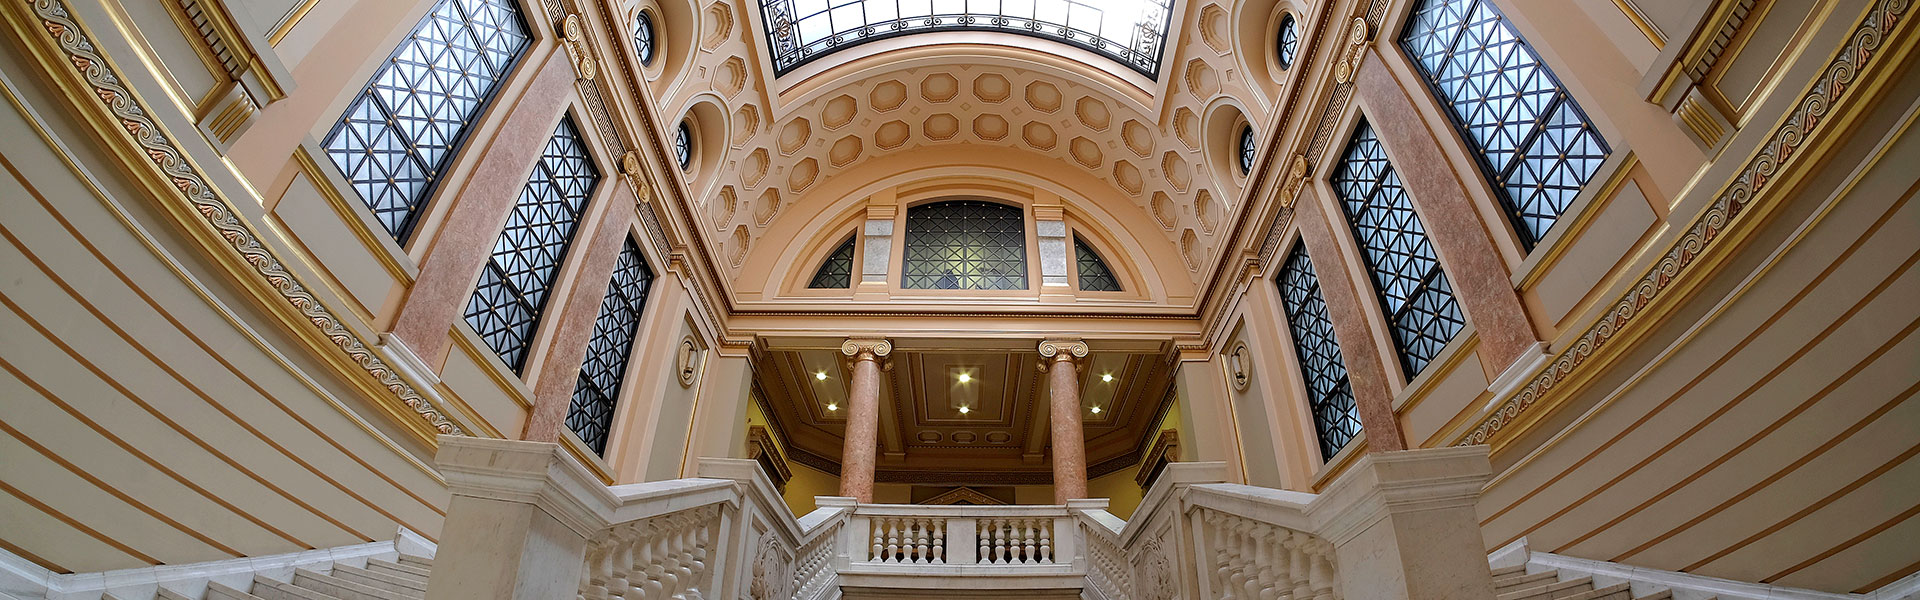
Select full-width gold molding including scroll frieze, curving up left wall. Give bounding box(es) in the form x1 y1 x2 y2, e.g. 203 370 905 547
4 0 467 440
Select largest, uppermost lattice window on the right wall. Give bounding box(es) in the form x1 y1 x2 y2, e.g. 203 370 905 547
1400 0 1611 250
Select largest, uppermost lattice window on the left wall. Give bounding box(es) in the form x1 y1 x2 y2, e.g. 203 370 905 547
321 0 530 240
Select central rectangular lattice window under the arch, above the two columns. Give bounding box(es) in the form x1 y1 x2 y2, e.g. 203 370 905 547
904 200 1027 290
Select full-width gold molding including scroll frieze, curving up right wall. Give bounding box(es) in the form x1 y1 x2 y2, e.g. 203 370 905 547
1455 0 1914 456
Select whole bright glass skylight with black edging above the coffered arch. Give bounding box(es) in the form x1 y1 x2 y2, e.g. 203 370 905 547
760 0 1173 79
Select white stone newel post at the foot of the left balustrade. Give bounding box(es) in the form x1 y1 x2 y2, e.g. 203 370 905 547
426 435 601 600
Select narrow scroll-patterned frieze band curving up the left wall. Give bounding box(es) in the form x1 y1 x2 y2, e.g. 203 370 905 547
27 0 467 435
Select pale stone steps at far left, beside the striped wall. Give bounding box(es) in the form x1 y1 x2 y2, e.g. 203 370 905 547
140 554 434 600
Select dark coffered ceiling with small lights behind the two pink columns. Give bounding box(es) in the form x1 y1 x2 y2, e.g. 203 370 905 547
755 340 1173 485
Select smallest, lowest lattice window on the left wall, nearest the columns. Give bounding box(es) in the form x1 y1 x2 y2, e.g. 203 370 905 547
566 238 653 456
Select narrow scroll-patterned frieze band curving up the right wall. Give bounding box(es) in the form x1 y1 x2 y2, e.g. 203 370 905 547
1455 0 1910 446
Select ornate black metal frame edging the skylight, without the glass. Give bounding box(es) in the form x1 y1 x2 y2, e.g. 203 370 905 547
760 0 1177 81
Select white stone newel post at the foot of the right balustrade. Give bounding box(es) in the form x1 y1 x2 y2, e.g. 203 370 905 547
1315 446 1494 600
